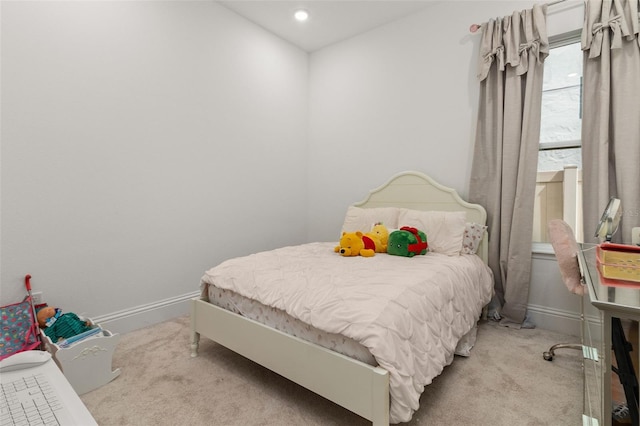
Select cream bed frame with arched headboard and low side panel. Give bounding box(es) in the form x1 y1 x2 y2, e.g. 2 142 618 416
191 172 488 426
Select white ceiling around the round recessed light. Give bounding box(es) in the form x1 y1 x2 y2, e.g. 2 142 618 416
218 0 433 52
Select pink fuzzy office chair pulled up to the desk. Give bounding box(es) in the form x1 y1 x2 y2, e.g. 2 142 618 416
542 219 585 361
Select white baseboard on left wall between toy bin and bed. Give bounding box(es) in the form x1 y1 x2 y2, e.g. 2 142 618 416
91 291 200 334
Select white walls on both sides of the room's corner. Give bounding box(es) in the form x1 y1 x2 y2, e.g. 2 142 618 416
0 1 581 338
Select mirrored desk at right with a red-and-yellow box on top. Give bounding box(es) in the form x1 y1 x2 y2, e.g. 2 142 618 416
578 244 640 426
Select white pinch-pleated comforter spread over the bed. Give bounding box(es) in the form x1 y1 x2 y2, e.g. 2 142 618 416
202 243 493 423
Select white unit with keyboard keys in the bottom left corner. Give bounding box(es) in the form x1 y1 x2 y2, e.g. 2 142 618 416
0 351 97 426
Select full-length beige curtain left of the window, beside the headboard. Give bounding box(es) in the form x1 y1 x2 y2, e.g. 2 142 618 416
469 5 549 328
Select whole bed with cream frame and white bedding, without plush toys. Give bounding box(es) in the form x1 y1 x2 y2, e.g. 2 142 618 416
191 171 493 425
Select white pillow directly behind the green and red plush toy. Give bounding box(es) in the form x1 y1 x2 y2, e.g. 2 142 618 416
398 209 467 256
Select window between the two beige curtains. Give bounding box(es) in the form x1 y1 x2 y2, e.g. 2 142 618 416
533 31 583 242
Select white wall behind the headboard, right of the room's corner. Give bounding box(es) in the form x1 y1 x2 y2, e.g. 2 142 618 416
309 1 582 334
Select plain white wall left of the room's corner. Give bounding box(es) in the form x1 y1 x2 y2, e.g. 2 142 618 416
0 1 308 328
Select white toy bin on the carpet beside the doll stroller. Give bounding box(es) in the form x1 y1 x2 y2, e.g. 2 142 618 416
40 318 120 395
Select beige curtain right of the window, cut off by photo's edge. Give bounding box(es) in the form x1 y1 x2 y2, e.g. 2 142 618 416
582 0 640 243
